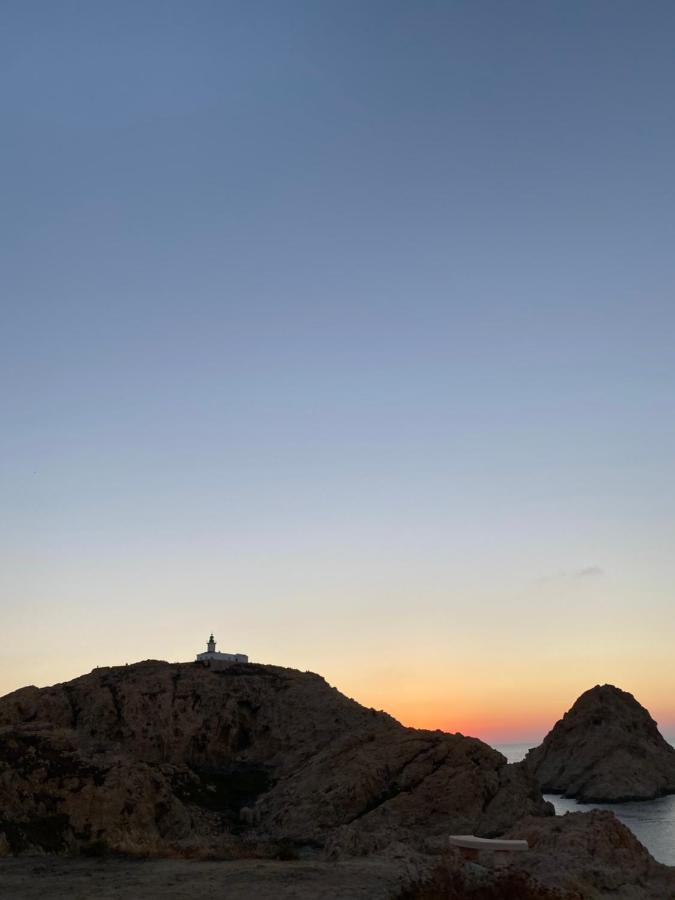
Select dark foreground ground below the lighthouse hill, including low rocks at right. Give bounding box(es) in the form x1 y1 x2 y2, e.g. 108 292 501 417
0 811 675 900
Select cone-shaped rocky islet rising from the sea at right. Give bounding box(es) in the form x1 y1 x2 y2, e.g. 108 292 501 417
525 684 675 803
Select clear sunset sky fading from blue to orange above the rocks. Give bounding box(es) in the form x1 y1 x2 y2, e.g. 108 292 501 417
0 0 675 743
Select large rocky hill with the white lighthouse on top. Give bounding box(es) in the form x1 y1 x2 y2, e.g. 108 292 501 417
0 661 551 855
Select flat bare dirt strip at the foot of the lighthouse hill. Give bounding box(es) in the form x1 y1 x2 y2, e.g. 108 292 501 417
0 856 426 900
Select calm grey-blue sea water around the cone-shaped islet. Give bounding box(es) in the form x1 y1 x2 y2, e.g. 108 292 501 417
495 740 675 866
